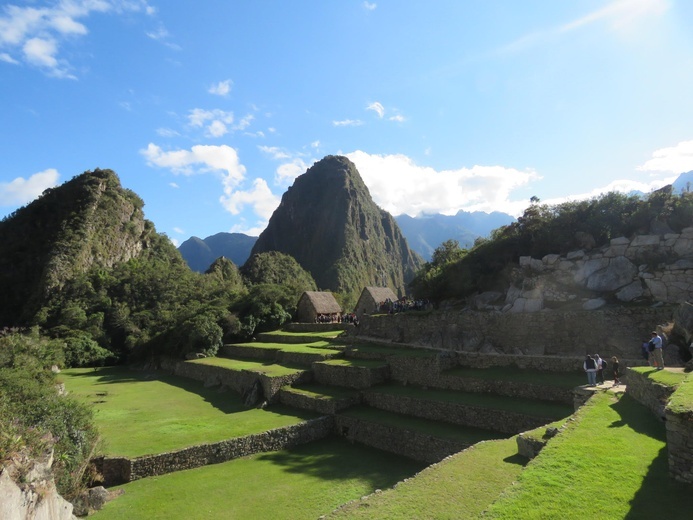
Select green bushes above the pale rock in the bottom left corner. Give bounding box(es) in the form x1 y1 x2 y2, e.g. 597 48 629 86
0 330 98 499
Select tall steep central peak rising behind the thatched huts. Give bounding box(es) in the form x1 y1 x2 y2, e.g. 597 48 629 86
252 156 422 294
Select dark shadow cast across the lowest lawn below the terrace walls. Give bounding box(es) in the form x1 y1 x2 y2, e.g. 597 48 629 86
258 436 427 489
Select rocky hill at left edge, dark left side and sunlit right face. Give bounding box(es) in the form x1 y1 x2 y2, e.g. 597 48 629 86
0 170 154 326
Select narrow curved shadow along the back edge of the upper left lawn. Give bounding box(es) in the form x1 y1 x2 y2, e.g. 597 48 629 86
66 367 316 420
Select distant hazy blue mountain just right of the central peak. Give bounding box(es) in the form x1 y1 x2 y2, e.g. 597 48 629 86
395 210 515 261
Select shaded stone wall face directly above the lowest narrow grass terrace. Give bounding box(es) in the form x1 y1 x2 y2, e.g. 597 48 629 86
363 391 553 435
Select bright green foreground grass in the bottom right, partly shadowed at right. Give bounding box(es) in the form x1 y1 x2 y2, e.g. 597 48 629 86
484 393 693 520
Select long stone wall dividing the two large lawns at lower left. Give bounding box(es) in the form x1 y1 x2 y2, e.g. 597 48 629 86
97 416 334 486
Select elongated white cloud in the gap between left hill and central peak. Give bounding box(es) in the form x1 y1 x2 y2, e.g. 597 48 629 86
140 143 245 186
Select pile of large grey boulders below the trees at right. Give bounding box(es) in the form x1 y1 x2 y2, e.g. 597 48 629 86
472 227 693 313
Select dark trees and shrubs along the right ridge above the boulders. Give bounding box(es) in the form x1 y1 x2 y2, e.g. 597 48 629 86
410 186 693 301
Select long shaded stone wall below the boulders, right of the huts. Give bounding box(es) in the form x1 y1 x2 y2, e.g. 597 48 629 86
348 307 672 360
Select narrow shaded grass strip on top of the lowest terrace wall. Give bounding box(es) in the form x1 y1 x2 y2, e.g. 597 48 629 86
339 406 506 442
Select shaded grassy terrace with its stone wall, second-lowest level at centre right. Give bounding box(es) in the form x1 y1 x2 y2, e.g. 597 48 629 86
363 384 573 435
